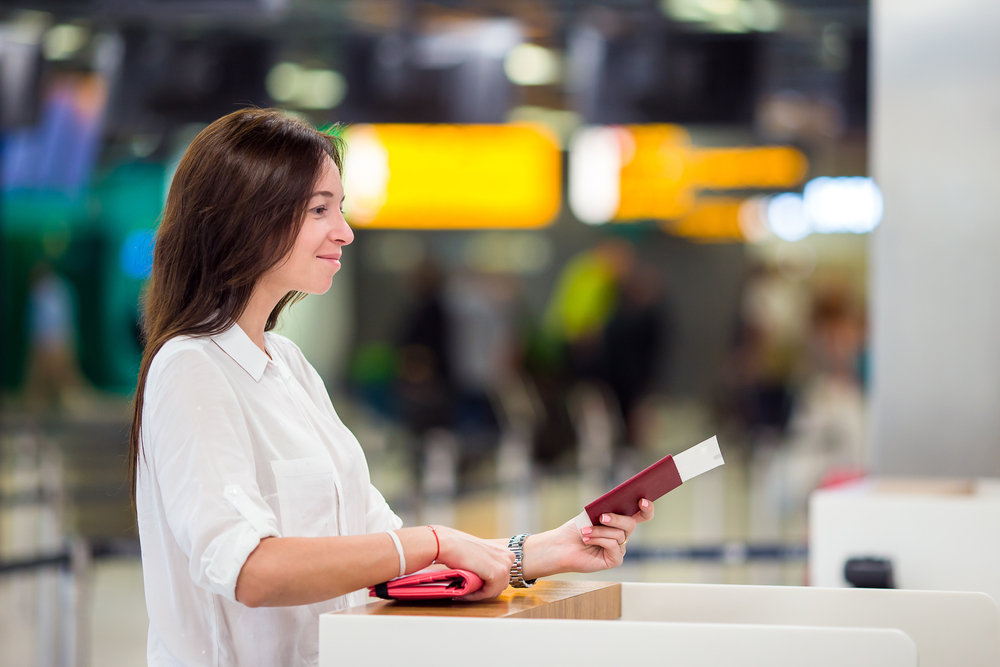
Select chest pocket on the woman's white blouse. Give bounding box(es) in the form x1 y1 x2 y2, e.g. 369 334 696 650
271 456 339 537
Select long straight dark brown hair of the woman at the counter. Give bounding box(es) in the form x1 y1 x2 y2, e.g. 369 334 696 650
129 109 343 504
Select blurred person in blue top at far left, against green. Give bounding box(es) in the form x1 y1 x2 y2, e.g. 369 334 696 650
25 261 84 413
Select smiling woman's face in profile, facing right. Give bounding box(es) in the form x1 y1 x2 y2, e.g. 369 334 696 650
265 157 354 294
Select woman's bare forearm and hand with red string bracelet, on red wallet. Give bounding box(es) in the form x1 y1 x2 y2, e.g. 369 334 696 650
236 526 514 607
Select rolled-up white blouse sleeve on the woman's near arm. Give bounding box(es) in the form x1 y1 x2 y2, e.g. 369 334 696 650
140 349 279 602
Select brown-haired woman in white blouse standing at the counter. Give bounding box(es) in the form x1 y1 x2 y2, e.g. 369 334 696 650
130 109 653 667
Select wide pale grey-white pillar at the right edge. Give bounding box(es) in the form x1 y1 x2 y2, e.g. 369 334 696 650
871 0 1000 476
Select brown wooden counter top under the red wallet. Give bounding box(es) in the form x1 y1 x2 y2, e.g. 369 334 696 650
337 580 622 621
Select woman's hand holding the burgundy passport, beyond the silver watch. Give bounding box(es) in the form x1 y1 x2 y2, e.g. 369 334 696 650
524 499 653 579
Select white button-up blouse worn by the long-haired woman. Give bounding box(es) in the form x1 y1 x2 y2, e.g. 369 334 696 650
136 325 402 667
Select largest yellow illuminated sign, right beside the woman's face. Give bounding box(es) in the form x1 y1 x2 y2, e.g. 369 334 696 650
344 124 562 229
